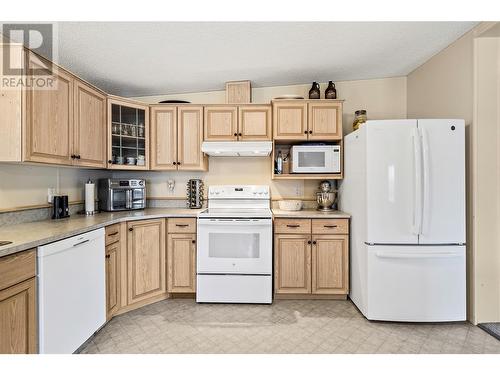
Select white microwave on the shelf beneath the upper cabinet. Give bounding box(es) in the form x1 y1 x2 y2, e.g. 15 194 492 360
290 145 340 173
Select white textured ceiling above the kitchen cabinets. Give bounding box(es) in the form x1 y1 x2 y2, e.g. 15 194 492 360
53 22 476 96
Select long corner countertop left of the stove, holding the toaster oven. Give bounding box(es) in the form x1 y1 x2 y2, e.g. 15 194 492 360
0 208 203 257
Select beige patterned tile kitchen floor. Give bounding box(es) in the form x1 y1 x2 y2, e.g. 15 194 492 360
81 299 500 353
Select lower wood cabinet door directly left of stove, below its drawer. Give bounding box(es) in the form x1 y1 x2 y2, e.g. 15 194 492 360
167 233 196 293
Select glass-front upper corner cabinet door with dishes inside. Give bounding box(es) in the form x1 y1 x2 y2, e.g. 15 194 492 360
108 99 149 169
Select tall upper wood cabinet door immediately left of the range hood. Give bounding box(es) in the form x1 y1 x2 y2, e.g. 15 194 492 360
177 106 208 171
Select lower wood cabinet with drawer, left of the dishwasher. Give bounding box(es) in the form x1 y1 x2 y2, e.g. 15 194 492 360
0 250 37 354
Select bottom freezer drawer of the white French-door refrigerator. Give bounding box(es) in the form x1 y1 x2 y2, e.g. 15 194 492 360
366 246 466 322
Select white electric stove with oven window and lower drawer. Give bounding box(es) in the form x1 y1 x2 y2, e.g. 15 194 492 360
196 185 273 303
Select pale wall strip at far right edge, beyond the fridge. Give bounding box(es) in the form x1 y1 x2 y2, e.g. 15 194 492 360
473 33 500 323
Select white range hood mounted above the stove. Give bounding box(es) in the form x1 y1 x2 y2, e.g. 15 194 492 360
201 141 273 157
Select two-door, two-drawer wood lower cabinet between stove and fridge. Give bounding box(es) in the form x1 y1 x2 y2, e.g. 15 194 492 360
274 219 349 298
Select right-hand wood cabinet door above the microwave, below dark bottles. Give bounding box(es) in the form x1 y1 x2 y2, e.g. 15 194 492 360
307 102 342 140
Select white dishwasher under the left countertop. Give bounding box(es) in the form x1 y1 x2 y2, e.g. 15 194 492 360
37 229 106 354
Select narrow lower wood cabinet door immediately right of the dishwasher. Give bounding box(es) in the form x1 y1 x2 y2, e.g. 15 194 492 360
105 242 121 320
